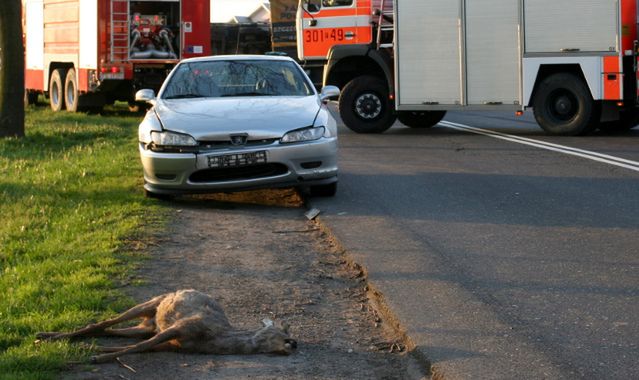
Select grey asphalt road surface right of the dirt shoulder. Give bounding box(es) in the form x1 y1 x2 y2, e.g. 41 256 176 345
312 108 639 379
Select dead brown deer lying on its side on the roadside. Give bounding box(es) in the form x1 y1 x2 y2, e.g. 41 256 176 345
36 289 297 363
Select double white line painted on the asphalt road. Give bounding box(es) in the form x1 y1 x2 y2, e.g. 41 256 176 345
439 121 639 172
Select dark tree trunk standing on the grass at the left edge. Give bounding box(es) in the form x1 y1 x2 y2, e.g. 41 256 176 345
0 0 24 138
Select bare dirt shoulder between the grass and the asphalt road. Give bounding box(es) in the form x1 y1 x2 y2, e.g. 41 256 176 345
70 191 428 379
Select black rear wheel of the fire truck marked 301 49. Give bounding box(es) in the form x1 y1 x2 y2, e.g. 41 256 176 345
533 73 601 136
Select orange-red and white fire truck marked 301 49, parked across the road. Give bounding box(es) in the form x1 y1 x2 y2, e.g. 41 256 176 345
297 0 638 135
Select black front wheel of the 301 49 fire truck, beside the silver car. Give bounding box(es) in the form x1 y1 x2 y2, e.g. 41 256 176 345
339 75 396 133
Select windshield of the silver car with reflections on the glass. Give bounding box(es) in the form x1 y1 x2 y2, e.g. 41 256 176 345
162 60 314 99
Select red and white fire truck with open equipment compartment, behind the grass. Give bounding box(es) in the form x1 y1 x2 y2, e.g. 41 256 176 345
23 0 211 112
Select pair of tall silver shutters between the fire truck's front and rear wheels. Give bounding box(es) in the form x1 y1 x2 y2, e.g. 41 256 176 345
395 0 522 110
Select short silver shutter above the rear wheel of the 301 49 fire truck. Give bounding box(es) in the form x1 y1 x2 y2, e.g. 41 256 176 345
524 0 619 53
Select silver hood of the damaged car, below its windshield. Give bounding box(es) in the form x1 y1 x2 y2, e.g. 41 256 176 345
155 96 321 141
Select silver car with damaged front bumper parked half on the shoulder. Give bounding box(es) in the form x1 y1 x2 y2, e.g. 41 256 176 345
136 55 339 197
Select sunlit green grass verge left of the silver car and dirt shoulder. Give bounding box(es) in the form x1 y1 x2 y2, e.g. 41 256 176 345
0 107 162 379
